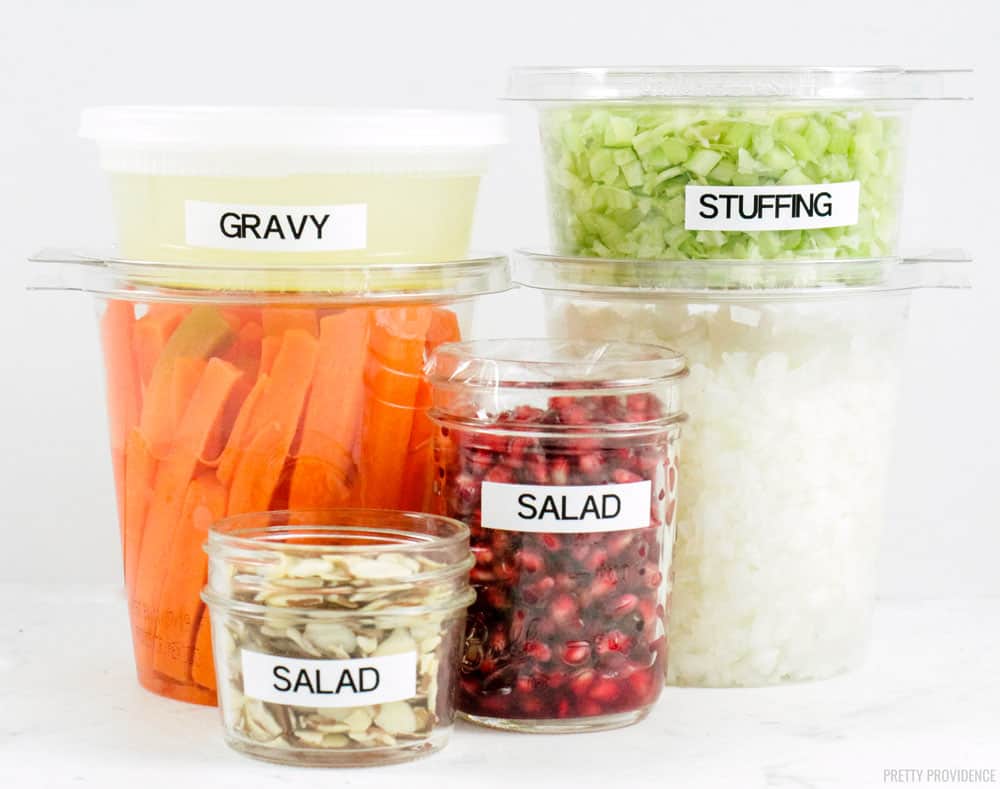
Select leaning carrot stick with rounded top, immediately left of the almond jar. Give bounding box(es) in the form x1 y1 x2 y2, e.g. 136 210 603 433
153 472 226 682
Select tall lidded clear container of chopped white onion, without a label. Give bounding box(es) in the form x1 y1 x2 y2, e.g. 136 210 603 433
517 253 968 686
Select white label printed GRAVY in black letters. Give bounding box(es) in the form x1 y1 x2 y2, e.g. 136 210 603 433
184 200 368 252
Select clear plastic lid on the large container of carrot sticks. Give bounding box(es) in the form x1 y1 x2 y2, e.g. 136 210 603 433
28 249 511 305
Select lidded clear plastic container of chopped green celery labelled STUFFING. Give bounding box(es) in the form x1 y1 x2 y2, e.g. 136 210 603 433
508 66 970 260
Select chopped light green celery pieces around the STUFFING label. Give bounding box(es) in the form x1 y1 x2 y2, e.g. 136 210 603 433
542 104 902 260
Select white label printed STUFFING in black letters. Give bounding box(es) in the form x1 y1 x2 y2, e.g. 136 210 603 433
684 181 861 230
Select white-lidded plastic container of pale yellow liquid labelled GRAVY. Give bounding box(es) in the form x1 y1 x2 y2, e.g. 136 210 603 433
80 106 505 266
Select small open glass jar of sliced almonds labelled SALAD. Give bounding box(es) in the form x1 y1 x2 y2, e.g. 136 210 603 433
203 509 473 767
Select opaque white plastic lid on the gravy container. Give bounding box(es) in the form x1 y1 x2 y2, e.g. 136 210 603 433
80 106 506 151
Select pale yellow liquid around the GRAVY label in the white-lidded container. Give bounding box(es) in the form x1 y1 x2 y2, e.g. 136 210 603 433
110 172 479 290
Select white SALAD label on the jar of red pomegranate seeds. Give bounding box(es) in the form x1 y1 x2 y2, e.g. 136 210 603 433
482 479 653 533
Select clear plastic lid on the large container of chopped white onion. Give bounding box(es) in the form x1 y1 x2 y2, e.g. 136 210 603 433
514 250 971 301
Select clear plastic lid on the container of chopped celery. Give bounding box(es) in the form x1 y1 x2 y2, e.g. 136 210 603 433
506 66 973 101
